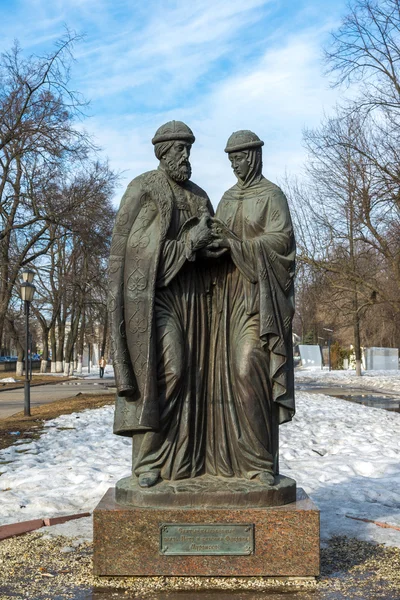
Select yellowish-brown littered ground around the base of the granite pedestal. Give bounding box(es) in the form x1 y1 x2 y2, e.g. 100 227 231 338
0 529 400 600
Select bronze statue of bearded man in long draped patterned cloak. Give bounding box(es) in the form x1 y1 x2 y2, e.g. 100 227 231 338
109 121 213 495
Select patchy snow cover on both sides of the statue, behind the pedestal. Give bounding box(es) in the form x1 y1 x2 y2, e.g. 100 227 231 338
0 384 400 547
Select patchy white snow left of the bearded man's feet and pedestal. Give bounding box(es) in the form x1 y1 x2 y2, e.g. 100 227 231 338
0 406 131 531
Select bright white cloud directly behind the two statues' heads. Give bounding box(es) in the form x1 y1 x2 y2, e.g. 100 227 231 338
92 25 338 205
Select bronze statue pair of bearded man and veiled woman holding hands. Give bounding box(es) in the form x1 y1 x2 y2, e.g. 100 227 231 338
109 121 295 502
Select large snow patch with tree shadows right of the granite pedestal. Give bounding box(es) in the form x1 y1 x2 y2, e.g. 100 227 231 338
280 392 400 546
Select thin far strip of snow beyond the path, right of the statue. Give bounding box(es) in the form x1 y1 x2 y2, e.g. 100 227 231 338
295 367 400 394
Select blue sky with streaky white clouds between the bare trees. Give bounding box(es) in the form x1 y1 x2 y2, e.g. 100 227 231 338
0 0 346 205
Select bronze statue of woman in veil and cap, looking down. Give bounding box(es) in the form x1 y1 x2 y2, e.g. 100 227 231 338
206 131 295 486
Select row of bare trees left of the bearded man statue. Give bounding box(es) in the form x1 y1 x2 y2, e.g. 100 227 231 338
0 31 117 373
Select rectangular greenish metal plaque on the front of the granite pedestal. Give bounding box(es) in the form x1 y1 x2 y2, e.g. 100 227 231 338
160 523 254 556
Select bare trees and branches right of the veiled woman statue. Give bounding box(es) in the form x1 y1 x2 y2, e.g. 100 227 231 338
286 0 400 373
